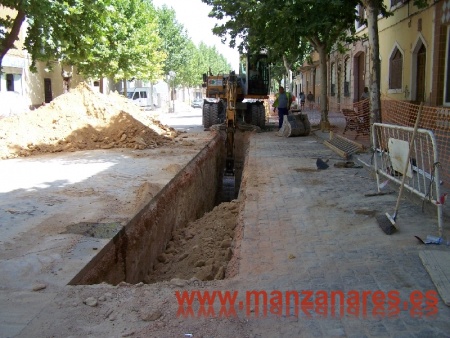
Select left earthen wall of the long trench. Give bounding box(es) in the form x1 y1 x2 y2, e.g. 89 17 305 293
69 133 224 285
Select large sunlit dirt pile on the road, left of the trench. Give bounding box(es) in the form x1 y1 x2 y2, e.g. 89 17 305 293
0 83 177 159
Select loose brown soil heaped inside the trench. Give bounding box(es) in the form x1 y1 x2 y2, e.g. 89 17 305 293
146 200 239 283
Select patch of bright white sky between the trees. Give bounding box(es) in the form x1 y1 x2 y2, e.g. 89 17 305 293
152 0 239 71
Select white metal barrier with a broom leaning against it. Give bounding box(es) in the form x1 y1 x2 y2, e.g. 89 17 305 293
372 123 444 236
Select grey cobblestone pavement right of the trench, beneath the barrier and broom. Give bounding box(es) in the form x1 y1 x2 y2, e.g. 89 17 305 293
237 132 450 337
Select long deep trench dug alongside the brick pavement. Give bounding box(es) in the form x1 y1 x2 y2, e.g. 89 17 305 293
69 131 250 285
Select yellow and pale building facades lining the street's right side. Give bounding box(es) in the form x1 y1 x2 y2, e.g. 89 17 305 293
296 0 444 111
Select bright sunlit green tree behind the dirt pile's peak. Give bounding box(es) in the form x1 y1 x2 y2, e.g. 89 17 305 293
77 0 166 81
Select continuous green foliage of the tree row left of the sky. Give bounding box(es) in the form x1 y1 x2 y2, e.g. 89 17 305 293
0 0 237 86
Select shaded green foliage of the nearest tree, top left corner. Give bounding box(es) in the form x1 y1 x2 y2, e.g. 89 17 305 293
0 0 107 70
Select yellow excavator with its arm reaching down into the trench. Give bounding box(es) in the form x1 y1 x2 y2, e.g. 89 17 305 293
202 54 270 200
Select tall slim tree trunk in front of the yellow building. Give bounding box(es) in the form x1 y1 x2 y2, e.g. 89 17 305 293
363 0 381 139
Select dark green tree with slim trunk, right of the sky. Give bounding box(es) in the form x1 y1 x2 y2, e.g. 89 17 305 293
202 0 358 129
